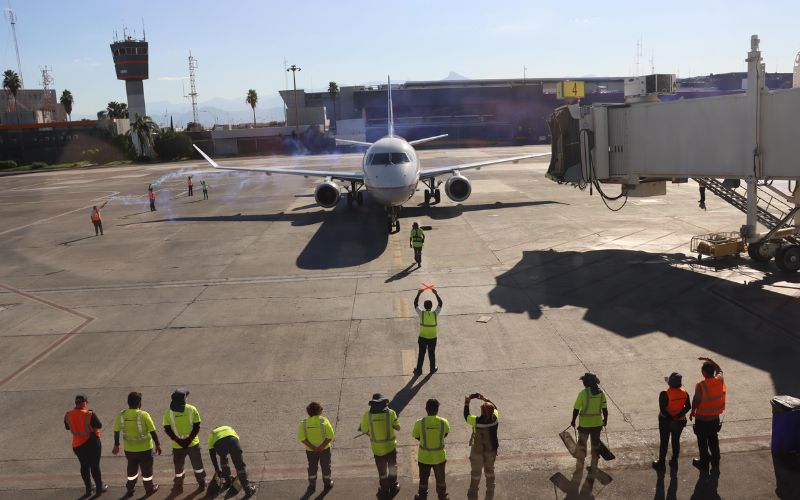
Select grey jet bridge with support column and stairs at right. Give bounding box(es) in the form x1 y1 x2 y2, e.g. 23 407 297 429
547 35 800 271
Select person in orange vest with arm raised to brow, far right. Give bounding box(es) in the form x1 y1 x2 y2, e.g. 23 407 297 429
689 358 727 470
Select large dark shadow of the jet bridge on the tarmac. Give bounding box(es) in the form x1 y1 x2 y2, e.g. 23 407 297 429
489 249 800 397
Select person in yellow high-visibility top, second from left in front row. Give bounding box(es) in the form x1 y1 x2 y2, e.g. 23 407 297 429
111 392 161 497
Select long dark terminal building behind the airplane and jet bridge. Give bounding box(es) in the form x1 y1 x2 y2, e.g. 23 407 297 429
281 72 792 147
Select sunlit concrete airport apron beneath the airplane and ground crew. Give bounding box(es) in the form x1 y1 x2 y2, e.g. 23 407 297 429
0 146 800 499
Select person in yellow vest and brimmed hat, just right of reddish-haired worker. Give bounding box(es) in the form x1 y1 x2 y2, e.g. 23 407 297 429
360 393 400 498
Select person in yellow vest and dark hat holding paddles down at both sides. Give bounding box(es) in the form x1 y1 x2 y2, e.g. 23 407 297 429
570 372 608 477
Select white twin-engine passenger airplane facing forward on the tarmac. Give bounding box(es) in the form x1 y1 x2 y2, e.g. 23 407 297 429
194 79 550 233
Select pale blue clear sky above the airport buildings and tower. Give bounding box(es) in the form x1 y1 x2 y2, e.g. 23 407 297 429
0 0 800 116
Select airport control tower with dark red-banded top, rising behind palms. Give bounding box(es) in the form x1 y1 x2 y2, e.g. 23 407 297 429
111 32 149 122
